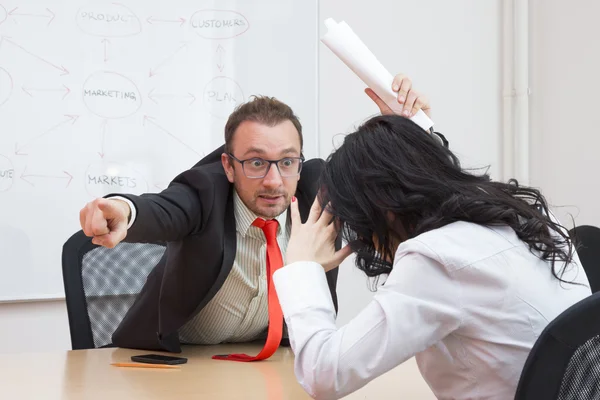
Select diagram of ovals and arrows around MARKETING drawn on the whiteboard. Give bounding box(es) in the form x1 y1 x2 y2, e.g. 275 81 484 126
0 2 250 197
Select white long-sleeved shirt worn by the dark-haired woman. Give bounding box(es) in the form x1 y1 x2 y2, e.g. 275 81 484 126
274 222 591 399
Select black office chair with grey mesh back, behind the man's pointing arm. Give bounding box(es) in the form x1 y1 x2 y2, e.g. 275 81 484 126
62 231 165 350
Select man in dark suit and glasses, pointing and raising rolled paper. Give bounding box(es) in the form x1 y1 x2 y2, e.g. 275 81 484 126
80 75 436 357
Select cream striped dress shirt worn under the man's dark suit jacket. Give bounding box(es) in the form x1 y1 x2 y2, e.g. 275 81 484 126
111 190 290 344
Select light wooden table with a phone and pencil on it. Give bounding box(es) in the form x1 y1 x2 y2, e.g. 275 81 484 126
0 344 435 400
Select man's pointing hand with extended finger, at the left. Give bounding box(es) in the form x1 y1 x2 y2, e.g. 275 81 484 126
79 198 131 249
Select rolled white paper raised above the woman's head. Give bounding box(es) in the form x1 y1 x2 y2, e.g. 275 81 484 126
321 18 433 130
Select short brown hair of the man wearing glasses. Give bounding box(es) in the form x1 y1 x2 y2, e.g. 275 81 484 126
225 96 304 153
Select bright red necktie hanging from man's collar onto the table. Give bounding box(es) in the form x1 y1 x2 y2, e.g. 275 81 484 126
213 218 283 361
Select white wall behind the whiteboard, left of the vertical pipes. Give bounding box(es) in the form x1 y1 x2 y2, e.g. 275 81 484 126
0 0 502 352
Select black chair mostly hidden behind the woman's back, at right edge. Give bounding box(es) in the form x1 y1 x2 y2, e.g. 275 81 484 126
569 225 600 293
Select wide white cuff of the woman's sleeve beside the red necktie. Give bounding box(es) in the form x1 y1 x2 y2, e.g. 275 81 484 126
273 261 335 316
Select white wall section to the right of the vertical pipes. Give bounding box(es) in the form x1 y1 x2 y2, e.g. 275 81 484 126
530 0 600 228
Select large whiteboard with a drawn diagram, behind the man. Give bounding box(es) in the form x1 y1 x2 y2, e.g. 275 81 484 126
0 0 318 301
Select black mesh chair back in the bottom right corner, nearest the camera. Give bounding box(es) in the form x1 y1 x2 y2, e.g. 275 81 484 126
515 292 600 400
